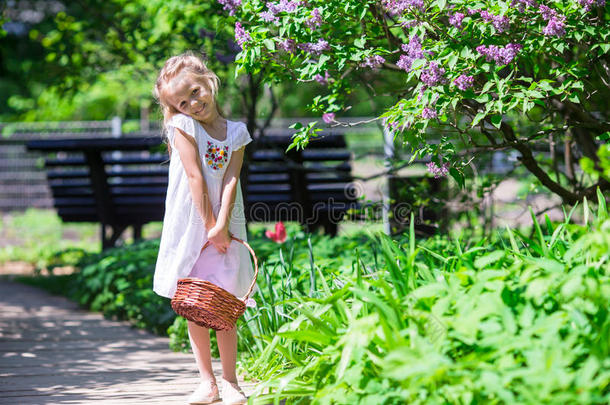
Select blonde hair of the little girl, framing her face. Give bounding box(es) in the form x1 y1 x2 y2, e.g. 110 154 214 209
153 51 223 150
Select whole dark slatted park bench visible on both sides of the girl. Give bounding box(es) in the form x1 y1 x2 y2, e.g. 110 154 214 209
27 131 355 248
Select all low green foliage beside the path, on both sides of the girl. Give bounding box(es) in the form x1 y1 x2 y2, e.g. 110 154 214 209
5 194 610 404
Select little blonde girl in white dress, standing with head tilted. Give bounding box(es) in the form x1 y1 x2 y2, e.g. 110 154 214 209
154 52 254 404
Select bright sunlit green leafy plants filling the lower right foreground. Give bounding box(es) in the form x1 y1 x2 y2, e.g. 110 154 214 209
244 193 610 404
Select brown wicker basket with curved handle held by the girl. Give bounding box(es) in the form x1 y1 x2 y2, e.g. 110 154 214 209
172 236 258 330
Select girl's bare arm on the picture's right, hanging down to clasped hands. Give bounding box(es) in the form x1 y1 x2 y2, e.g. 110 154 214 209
208 147 244 252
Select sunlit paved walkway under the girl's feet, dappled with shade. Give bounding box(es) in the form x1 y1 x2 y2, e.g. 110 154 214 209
0 279 253 405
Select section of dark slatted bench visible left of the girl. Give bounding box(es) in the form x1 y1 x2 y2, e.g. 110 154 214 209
27 137 168 248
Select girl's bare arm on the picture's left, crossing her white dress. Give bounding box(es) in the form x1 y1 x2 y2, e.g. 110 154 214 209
174 129 216 231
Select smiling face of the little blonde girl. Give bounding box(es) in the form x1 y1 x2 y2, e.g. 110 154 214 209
167 71 218 123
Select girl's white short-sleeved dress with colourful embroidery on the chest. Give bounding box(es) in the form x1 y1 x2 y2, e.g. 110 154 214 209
153 114 256 298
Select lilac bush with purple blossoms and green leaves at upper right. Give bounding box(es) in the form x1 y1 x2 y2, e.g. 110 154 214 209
229 0 610 203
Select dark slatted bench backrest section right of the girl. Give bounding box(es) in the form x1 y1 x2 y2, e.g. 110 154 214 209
245 135 355 223
